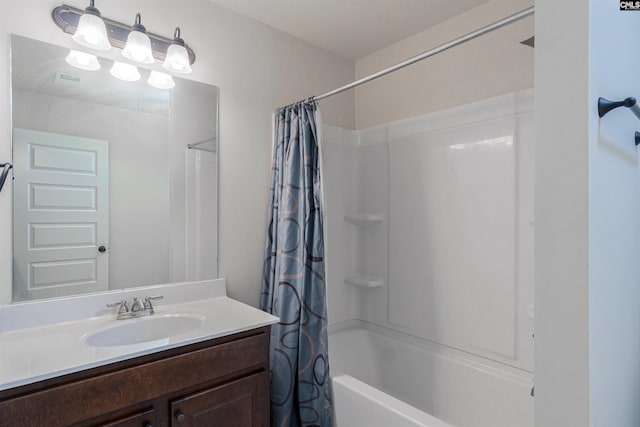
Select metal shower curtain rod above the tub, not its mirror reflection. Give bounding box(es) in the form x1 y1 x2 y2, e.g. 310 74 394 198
300 6 535 102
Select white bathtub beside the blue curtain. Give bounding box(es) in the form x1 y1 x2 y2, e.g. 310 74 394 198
329 321 533 427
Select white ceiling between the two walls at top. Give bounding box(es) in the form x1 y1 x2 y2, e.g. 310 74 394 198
210 0 488 60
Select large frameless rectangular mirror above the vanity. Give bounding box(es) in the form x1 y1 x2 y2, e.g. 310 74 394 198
11 35 218 302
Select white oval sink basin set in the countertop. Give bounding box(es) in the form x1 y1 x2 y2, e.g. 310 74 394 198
85 315 202 347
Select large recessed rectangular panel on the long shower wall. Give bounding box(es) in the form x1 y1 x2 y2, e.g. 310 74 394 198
389 118 517 358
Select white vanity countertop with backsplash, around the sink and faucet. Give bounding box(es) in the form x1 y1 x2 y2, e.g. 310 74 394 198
0 279 278 390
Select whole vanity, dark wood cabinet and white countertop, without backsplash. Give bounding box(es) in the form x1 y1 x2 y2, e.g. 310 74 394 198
0 281 277 427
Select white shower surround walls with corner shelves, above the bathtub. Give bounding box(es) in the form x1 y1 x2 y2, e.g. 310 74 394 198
323 91 534 372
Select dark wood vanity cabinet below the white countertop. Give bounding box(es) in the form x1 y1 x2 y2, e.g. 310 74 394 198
0 327 269 427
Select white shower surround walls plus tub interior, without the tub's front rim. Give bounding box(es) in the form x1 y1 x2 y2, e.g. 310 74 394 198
323 91 535 426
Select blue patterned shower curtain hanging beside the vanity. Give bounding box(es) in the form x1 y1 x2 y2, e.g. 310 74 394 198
260 102 332 427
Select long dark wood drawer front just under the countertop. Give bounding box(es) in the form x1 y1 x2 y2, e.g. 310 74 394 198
0 329 269 427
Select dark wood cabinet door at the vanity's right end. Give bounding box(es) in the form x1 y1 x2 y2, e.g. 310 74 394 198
171 372 269 427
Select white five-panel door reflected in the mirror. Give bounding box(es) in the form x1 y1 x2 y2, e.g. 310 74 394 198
13 128 109 301
